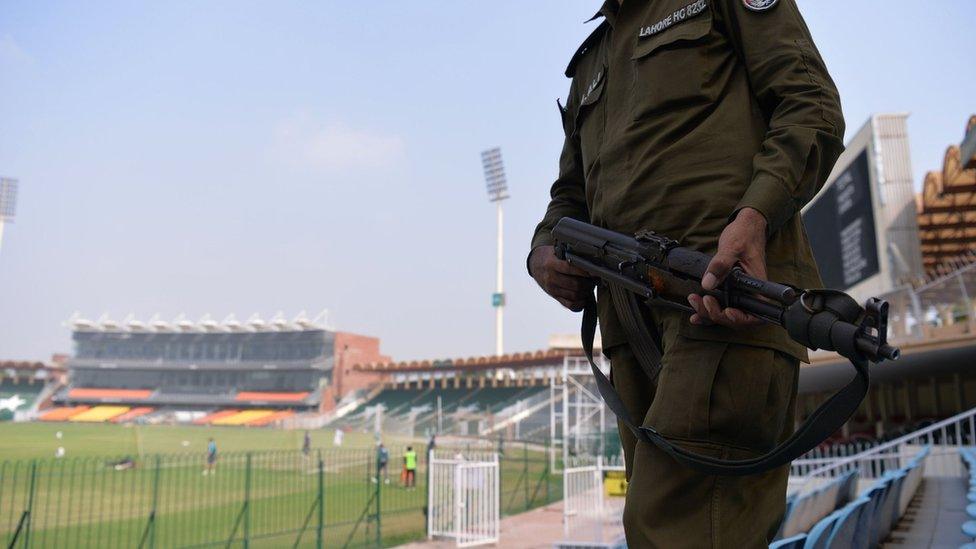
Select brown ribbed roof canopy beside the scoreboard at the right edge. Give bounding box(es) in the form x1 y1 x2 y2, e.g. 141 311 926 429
916 115 976 273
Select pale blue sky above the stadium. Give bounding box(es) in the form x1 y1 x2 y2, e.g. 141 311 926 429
0 0 976 359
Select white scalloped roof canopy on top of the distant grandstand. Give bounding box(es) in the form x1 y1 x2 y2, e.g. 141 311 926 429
67 311 332 333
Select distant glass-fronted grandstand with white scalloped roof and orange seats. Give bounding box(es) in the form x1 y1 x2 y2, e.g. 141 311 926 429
38 315 385 426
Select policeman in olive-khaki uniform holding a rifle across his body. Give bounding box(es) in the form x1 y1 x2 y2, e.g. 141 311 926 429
528 0 844 547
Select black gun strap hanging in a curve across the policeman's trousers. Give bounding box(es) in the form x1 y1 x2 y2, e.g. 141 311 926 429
581 297 868 476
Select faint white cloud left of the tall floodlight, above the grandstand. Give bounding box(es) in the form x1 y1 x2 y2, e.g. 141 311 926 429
272 116 405 172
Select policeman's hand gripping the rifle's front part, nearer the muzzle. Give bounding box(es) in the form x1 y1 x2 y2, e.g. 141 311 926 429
688 208 766 328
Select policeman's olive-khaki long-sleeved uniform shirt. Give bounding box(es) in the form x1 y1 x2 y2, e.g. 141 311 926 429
532 0 844 360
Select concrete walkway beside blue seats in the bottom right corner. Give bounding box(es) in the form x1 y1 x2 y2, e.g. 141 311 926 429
884 477 972 549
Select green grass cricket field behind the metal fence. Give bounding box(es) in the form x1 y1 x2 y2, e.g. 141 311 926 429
0 423 561 547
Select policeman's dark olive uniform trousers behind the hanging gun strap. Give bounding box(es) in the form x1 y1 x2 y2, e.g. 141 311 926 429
606 314 799 549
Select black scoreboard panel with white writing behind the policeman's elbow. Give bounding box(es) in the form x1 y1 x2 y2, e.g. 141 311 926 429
803 150 879 290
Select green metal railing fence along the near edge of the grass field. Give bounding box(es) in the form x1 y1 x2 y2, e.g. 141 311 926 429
0 442 562 548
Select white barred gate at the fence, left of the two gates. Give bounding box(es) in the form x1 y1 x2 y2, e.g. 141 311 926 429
427 452 501 547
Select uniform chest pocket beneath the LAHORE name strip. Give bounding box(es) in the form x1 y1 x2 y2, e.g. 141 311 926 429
631 8 713 120
